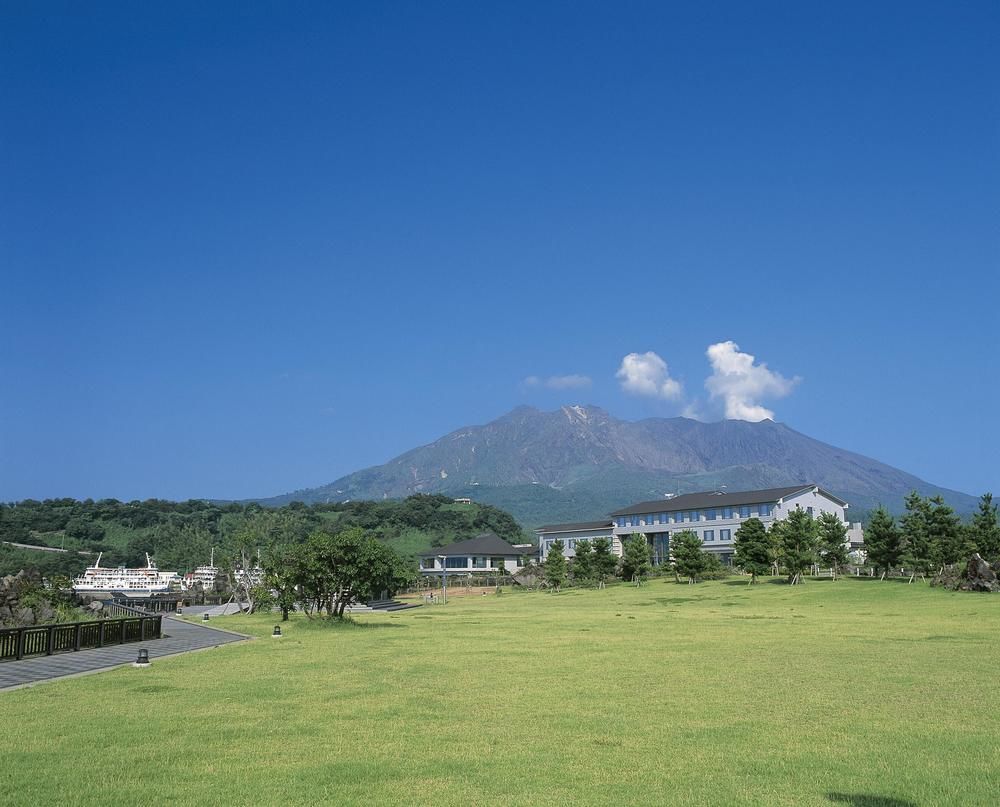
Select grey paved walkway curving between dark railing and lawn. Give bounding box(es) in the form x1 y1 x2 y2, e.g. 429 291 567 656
0 618 246 690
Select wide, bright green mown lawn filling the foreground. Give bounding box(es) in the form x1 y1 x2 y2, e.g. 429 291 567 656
0 580 1000 807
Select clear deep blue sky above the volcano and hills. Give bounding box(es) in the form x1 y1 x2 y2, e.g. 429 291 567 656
0 2 1000 500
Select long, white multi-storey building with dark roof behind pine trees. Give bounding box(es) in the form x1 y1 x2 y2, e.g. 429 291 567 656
537 485 860 564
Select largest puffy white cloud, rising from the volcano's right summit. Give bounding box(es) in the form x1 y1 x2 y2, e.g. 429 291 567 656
705 341 801 421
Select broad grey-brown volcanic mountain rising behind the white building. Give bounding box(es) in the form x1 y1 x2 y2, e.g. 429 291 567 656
256 404 976 526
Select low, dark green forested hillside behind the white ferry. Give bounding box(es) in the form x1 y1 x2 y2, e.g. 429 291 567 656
0 495 529 576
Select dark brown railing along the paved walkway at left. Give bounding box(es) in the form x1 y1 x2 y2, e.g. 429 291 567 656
0 614 163 661
